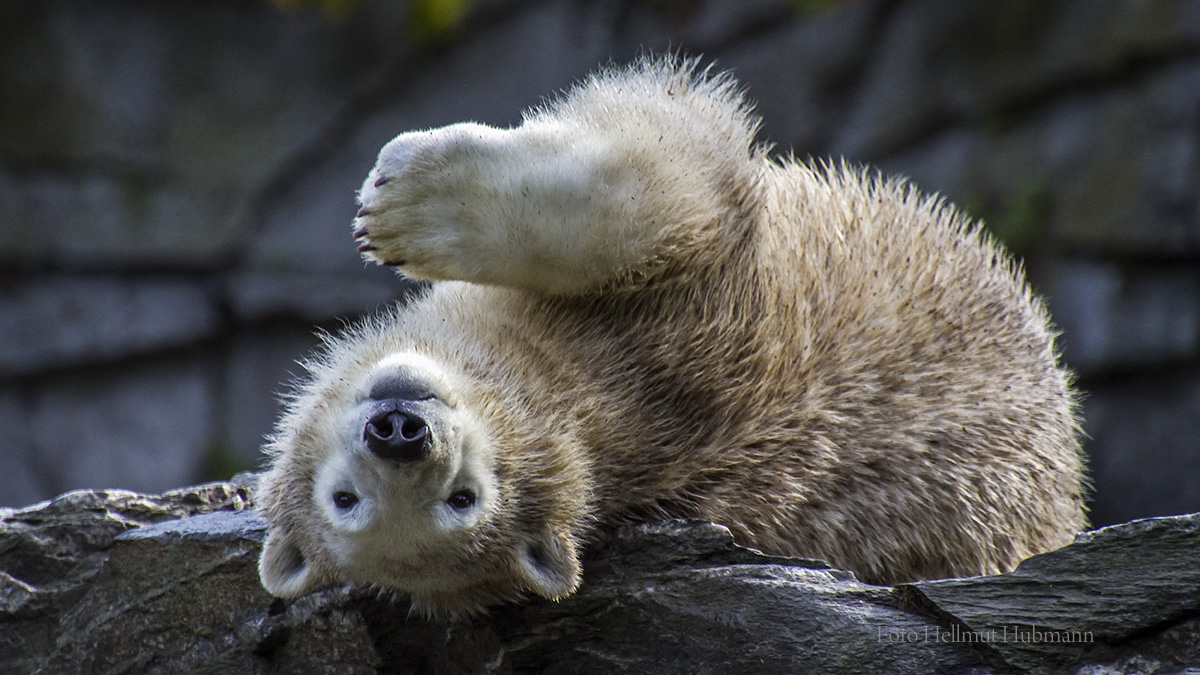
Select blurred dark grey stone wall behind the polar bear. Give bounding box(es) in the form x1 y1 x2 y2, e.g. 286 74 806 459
0 0 1200 524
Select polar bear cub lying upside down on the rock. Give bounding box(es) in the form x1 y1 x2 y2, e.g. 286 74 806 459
258 60 1084 614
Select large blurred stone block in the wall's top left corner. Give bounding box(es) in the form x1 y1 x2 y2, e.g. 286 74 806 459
0 0 404 268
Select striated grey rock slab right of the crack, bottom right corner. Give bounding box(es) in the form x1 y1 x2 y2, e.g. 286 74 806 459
901 514 1200 669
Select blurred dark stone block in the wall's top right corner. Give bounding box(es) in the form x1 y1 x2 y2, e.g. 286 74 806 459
834 0 1200 159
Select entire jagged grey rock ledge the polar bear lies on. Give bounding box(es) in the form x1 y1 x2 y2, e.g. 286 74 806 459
0 476 1200 675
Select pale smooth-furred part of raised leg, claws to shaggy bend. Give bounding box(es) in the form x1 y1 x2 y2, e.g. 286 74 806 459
354 118 691 293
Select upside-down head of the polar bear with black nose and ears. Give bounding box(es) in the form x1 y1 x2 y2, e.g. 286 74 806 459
257 345 580 615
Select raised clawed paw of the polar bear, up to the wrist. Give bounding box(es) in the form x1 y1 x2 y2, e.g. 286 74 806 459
354 124 509 279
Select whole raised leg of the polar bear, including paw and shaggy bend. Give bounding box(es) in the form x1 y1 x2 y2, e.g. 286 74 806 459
354 72 762 293
